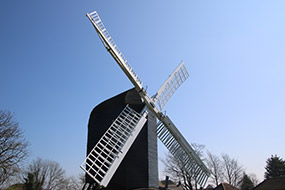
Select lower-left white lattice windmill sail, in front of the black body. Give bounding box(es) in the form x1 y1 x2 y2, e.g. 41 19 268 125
81 105 147 187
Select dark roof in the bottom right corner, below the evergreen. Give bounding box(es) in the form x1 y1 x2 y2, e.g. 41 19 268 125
254 177 285 190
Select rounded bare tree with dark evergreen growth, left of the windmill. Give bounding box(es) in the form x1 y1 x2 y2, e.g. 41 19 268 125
24 158 68 190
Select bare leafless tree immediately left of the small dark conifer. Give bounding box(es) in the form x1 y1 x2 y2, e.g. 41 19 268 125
222 154 244 187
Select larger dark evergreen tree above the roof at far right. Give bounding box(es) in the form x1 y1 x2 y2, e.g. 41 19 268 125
264 155 285 179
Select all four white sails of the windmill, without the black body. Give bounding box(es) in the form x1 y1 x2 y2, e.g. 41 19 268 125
81 11 210 190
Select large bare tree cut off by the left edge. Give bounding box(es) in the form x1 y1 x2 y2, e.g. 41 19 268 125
0 110 28 186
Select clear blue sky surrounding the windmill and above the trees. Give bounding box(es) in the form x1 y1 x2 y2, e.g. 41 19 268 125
0 0 285 184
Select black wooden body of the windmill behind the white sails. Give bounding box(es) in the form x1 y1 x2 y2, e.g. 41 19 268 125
86 88 158 190
